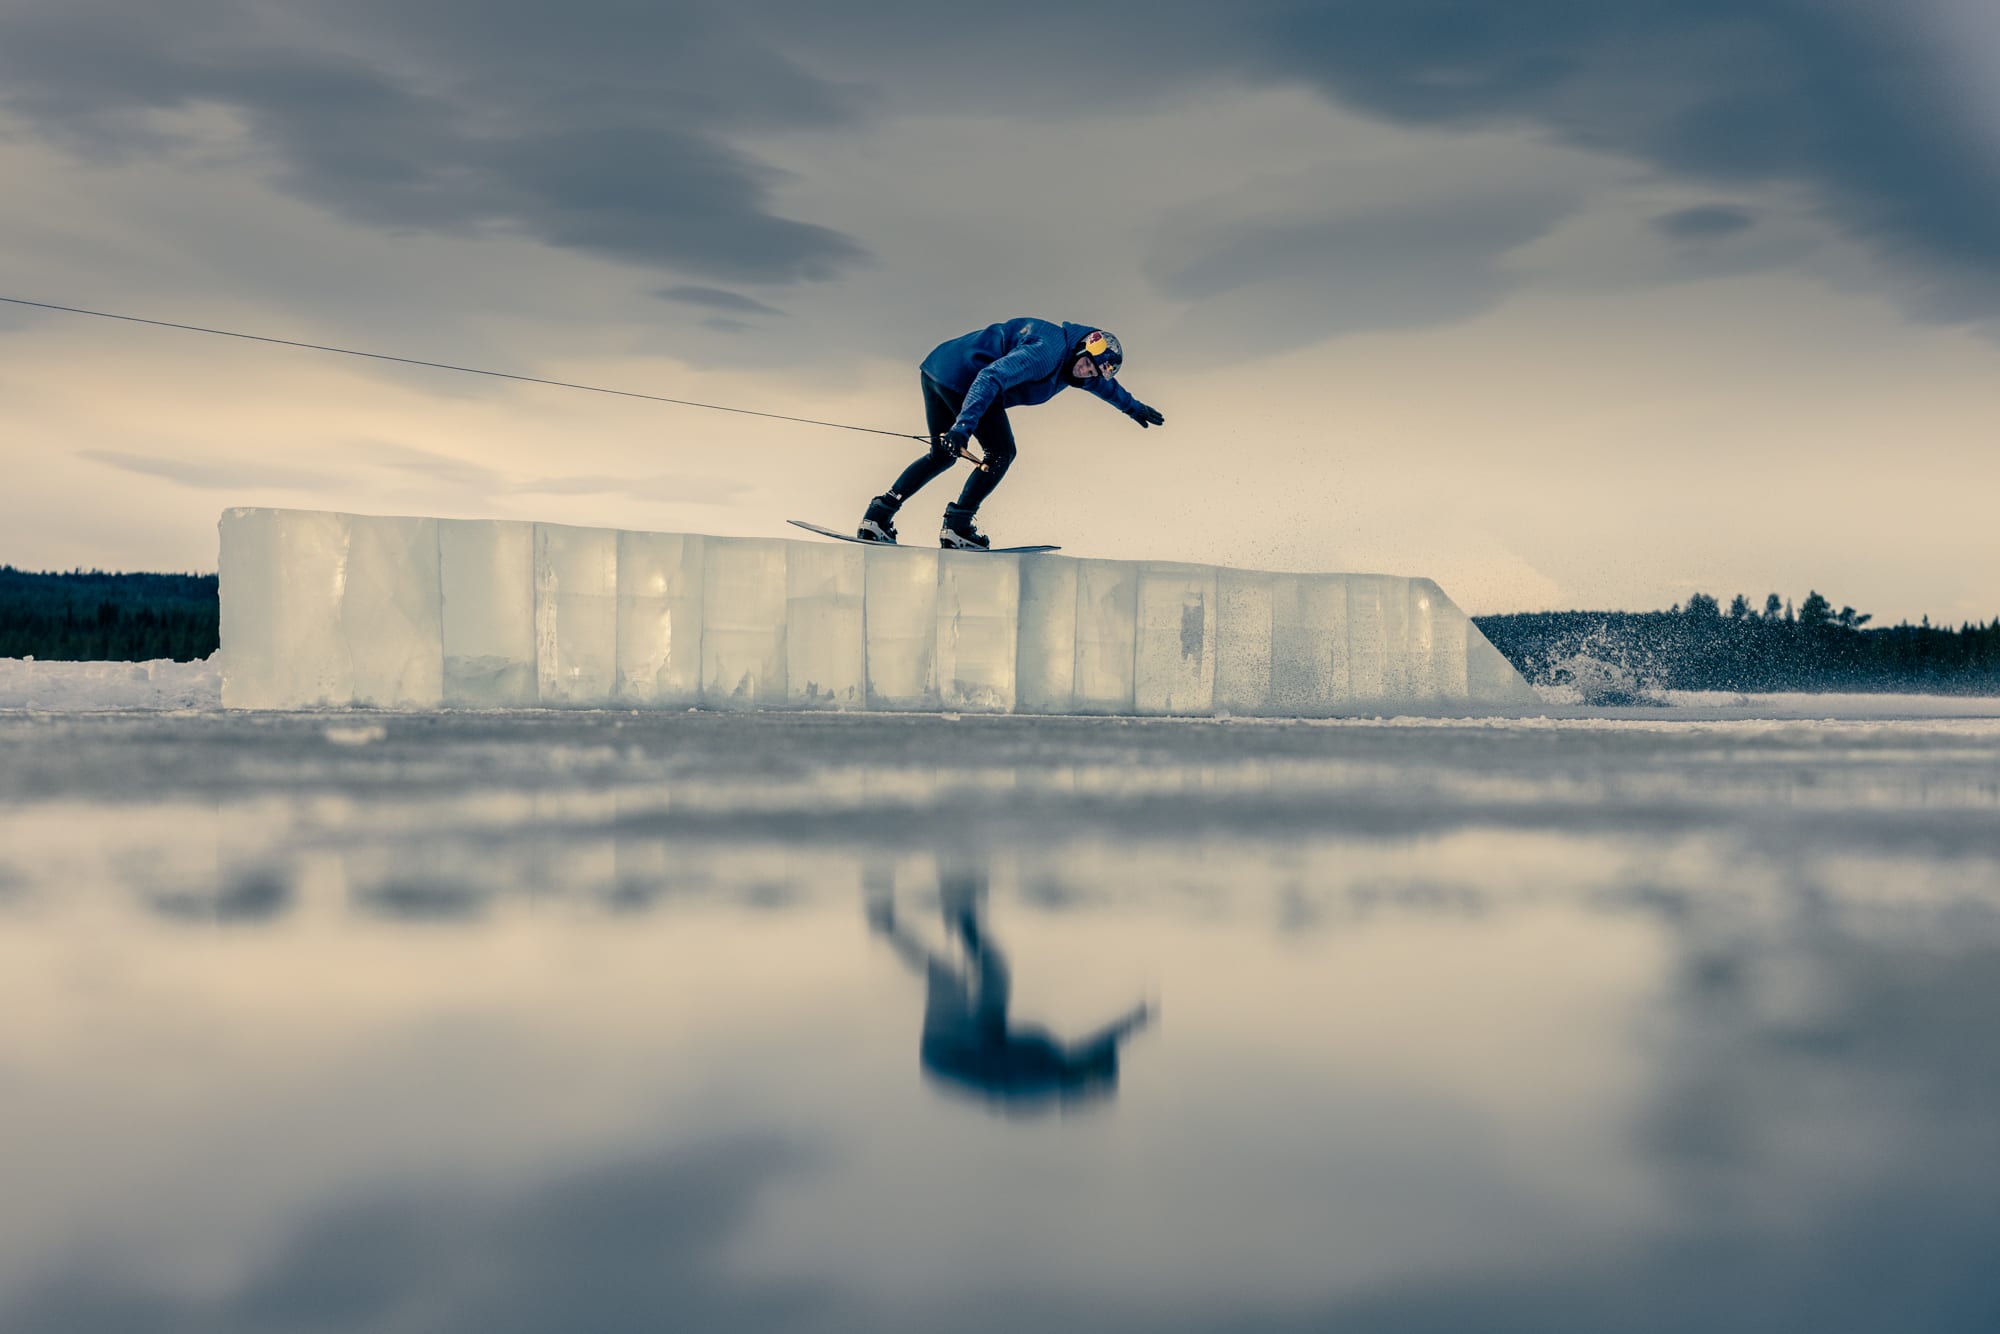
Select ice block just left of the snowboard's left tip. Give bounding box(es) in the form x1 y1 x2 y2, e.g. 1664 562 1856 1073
702 538 788 708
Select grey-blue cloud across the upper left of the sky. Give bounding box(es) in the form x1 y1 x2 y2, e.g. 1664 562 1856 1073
0 0 866 282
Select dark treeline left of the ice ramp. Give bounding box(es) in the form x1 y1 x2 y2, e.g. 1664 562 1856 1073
0 566 220 662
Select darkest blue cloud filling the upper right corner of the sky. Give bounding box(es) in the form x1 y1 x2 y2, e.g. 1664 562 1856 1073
1250 0 2000 318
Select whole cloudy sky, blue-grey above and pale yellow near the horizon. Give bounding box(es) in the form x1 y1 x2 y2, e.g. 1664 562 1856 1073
0 0 2000 622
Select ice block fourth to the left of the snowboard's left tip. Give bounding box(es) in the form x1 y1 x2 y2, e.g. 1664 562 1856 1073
438 518 540 708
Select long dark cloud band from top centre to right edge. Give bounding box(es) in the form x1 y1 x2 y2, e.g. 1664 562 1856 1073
770 0 2000 320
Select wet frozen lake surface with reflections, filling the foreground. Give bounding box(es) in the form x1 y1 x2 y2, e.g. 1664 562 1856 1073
0 698 2000 1334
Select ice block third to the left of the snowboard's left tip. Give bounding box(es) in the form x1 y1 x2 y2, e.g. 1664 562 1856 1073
534 524 618 708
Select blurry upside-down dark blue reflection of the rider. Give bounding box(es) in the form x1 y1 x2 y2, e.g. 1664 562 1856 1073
868 872 1152 1110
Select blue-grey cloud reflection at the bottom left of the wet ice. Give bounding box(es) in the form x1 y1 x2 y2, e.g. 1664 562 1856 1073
0 1138 830 1334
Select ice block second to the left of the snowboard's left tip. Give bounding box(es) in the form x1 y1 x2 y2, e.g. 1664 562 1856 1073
618 532 706 708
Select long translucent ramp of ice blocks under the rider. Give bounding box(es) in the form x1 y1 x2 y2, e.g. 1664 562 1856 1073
220 510 1536 718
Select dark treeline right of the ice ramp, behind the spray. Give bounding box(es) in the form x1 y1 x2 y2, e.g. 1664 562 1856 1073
1476 592 2000 694
